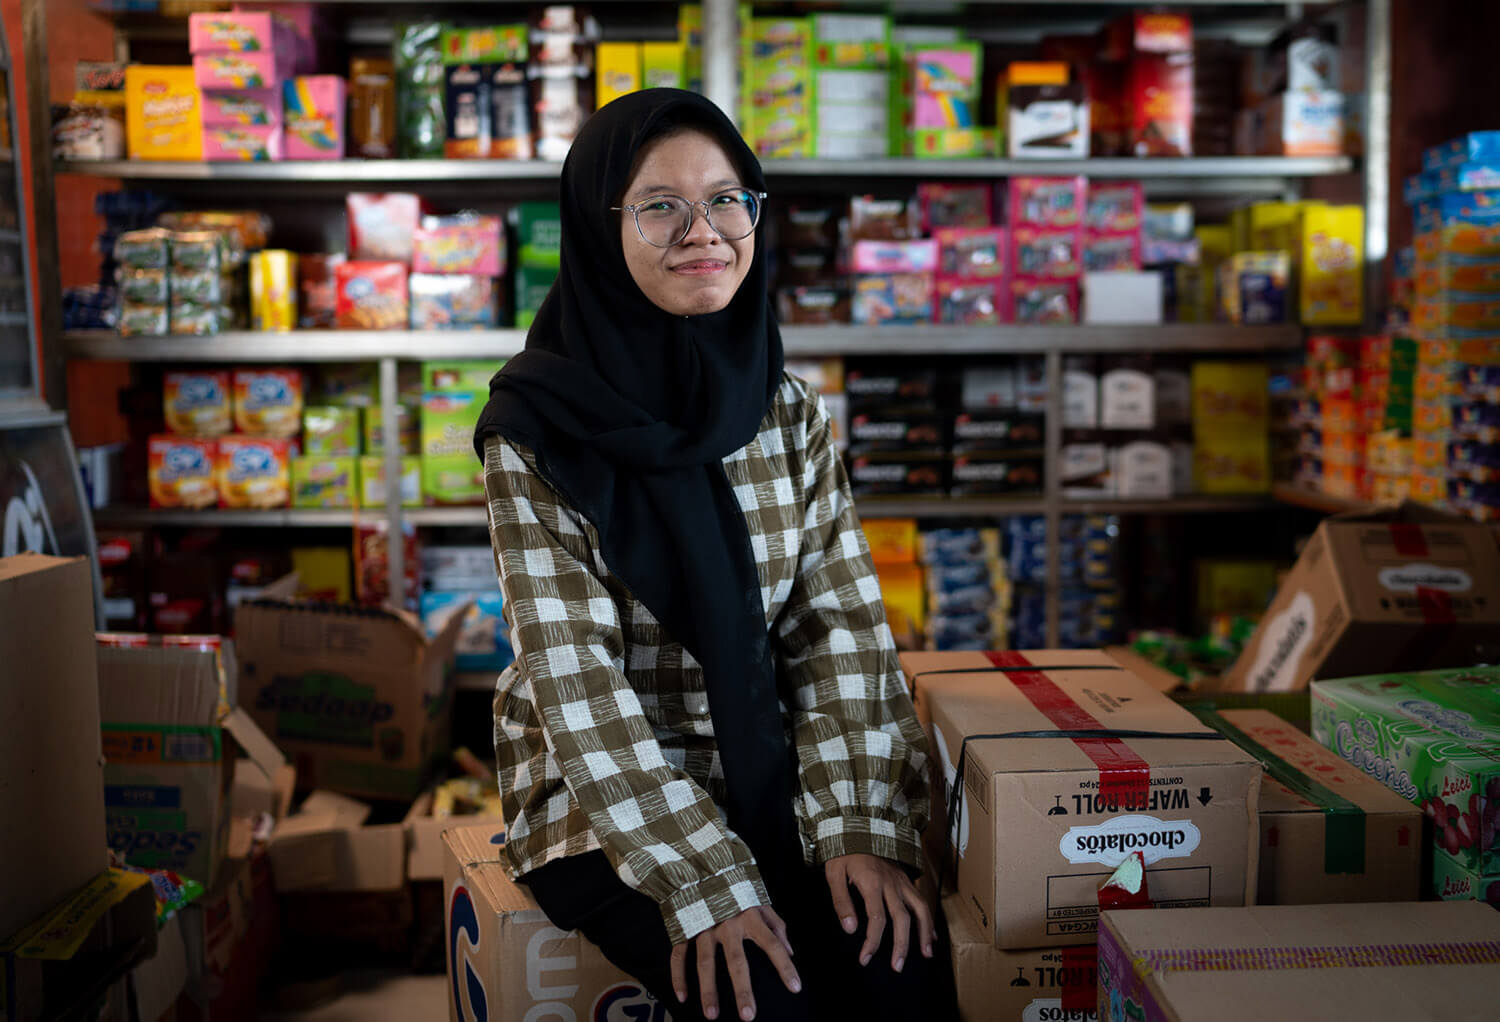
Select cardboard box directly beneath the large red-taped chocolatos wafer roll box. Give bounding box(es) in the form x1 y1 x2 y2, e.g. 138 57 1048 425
942 894 1098 1022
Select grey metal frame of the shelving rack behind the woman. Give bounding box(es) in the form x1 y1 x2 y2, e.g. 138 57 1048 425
23 0 1391 645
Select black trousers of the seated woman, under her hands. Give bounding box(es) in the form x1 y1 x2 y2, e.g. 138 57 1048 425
522 851 957 1022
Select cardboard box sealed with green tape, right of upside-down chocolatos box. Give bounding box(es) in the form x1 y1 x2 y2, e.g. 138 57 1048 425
1197 710 1422 905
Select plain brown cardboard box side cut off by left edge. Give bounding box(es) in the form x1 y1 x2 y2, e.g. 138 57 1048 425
0 554 110 939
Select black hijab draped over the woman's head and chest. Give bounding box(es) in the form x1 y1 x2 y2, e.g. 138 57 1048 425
474 89 801 900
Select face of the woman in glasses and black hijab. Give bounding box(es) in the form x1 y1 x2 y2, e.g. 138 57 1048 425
620 131 755 315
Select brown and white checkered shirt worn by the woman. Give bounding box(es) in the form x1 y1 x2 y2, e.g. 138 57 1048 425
485 375 927 942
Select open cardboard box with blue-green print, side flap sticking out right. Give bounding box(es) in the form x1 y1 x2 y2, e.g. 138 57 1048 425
98 642 285 887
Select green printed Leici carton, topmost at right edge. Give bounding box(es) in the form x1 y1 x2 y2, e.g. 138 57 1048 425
1313 668 1500 876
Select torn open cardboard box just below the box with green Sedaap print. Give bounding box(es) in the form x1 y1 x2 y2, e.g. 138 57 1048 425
270 791 407 894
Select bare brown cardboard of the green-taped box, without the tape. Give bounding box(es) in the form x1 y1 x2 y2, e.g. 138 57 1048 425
1220 710 1422 905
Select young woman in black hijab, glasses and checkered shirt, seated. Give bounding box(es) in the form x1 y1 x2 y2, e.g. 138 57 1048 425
474 89 947 1020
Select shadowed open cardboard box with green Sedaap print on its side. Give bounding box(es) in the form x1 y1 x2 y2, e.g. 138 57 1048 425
236 600 462 798
